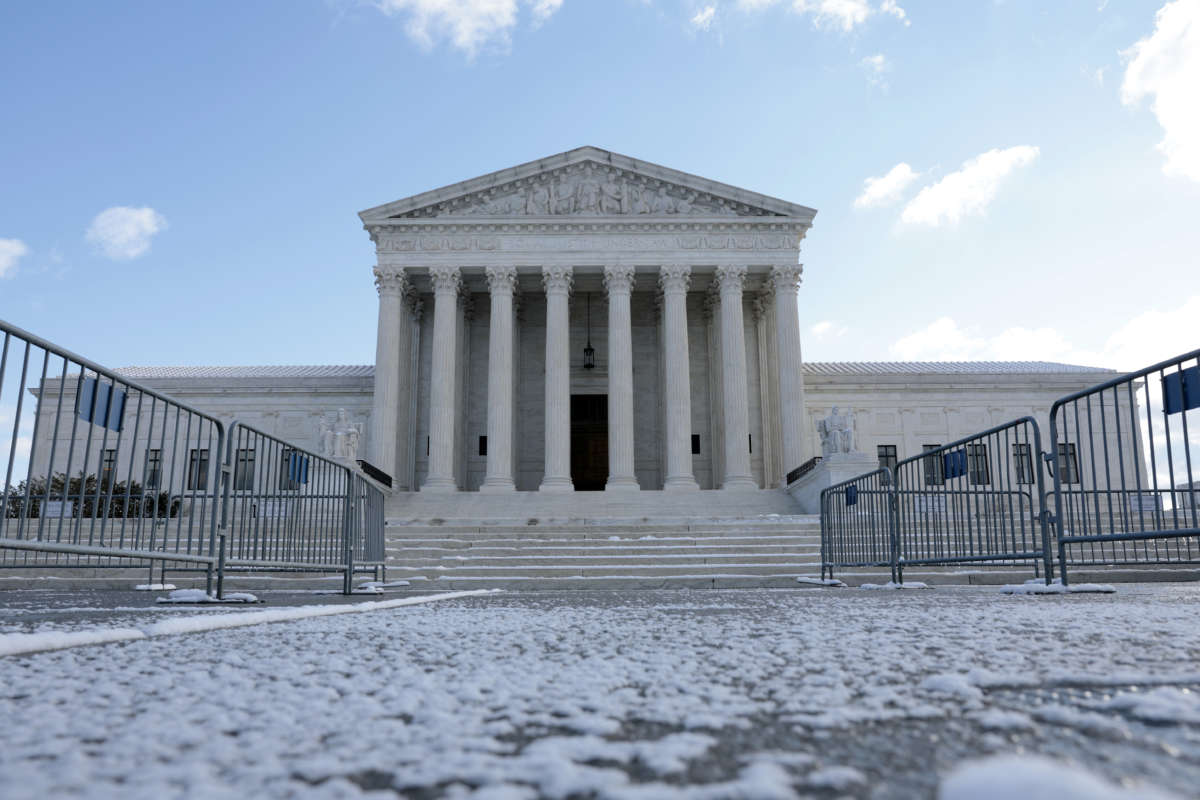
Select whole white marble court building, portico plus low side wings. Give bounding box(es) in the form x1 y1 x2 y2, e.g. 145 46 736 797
70 148 1111 516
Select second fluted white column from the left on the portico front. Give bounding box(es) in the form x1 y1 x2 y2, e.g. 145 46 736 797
421 266 462 492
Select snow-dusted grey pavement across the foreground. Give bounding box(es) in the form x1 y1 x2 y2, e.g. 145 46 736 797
0 587 1200 800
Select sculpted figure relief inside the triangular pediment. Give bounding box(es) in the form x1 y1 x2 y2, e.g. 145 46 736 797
398 162 776 218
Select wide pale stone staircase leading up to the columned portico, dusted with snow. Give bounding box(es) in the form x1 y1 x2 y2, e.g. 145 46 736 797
386 491 821 589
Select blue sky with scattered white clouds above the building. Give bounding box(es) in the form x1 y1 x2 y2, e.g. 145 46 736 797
0 0 1200 368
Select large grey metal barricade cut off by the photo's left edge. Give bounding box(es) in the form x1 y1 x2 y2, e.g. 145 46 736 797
0 320 224 590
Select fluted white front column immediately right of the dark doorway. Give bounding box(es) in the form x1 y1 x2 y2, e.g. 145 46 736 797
604 266 641 491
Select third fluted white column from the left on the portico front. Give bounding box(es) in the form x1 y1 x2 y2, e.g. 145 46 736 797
479 266 517 492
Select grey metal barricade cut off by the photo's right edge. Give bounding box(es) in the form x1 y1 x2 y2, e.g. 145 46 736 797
1045 350 1200 583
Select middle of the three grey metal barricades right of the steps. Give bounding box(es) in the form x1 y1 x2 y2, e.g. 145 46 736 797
895 417 1054 583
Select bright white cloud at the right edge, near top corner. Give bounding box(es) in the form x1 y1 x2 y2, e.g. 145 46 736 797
1121 0 1200 181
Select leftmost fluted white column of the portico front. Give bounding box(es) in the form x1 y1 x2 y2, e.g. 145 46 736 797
371 266 412 486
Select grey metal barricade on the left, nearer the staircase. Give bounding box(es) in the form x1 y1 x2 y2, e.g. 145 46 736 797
221 422 384 593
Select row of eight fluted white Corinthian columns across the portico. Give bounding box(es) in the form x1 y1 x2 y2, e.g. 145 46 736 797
371 264 804 492
